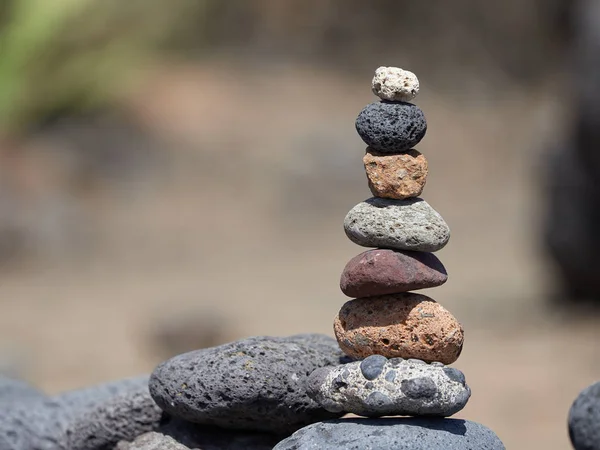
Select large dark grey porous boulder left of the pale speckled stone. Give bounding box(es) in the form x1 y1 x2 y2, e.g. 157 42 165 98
149 335 343 433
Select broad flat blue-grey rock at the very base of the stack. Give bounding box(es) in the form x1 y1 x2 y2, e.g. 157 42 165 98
273 417 505 450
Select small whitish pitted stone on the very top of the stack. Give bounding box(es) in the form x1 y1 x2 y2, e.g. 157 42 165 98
371 66 419 102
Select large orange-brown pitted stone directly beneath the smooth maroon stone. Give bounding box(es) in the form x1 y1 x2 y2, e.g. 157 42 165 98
333 293 464 364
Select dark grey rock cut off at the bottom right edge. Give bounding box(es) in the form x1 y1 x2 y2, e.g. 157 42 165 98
569 382 600 450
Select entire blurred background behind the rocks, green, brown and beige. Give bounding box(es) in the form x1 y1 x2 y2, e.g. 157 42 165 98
0 0 600 449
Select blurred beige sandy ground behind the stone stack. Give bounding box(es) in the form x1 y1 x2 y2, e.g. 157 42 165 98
0 63 600 450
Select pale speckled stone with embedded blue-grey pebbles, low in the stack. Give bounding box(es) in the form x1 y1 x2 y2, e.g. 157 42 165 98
307 355 471 417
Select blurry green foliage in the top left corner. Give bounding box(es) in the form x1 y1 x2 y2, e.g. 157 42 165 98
0 0 207 134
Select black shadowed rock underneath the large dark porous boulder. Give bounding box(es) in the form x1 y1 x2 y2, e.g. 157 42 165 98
158 419 280 450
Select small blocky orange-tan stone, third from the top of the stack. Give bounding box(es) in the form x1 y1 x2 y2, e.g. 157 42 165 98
363 148 428 200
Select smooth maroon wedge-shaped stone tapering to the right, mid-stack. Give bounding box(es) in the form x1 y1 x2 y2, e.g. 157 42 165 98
340 249 448 297
